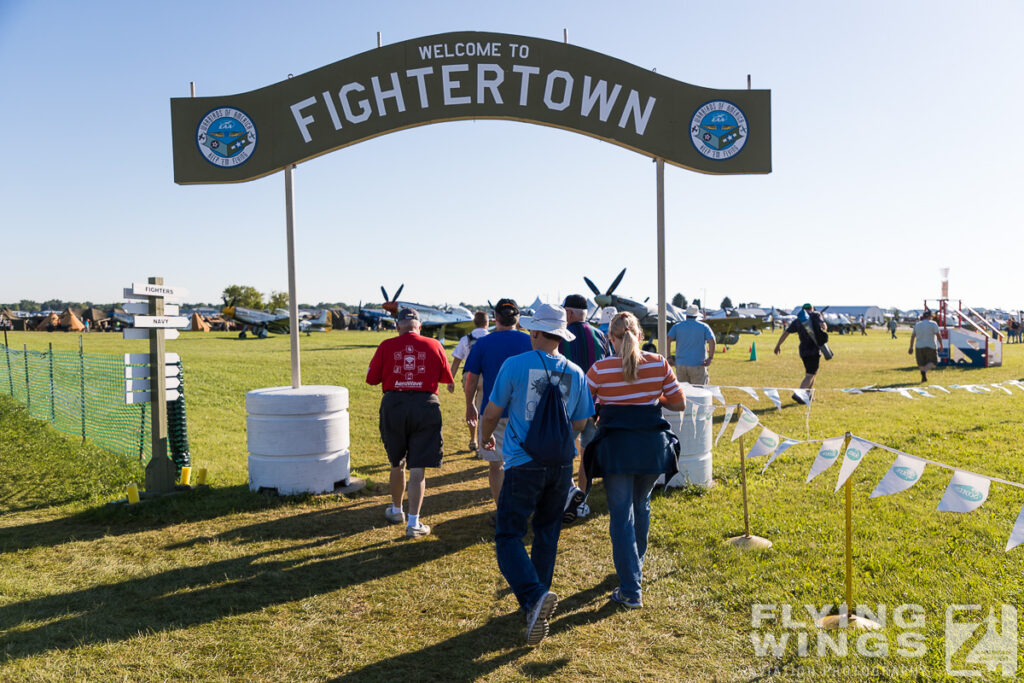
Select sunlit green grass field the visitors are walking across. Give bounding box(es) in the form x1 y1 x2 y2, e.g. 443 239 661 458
0 330 1024 681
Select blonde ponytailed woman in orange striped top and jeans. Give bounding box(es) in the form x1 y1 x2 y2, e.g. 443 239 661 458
585 312 686 608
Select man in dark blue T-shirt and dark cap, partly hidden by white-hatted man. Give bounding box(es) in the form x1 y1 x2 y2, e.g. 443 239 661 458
465 299 529 522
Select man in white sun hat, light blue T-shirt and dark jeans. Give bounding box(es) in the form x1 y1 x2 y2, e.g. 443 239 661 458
480 304 594 645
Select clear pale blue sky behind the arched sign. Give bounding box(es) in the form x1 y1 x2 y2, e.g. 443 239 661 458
0 0 1024 309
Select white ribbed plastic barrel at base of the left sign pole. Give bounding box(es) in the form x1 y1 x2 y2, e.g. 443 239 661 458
246 385 349 496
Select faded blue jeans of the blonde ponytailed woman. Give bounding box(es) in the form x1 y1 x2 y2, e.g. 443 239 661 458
604 474 657 600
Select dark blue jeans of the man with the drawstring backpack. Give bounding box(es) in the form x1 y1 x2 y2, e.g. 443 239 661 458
495 462 572 609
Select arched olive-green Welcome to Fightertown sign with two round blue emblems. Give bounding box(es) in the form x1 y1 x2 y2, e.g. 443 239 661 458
171 32 771 184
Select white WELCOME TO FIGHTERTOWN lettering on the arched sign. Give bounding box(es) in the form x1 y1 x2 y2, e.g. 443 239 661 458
290 42 656 143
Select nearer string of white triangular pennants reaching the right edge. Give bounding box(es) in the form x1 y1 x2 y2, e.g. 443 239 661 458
712 403 1024 552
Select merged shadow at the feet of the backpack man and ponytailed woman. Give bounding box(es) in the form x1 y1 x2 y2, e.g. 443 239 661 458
334 569 617 681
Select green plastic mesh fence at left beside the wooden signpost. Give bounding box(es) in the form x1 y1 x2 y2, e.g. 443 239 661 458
0 344 191 470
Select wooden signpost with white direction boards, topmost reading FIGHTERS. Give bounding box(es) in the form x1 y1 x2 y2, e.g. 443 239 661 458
124 278 188 494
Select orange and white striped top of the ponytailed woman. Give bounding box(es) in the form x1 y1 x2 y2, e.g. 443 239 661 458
587 351 682 405
